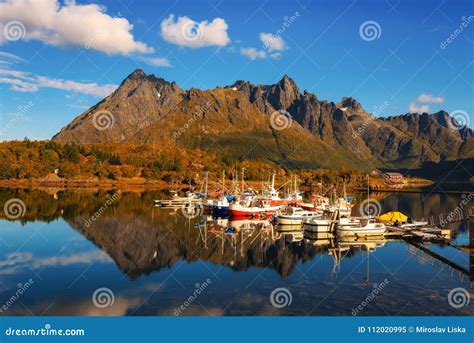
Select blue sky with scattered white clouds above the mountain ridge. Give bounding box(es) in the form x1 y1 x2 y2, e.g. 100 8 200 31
0 0 474 140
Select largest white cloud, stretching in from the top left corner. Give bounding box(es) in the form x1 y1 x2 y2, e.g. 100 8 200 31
0 0 153 55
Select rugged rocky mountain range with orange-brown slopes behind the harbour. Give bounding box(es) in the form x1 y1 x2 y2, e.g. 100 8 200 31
53 69 474 169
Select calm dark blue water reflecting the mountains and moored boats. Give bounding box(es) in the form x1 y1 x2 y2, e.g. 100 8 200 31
0 189 474 316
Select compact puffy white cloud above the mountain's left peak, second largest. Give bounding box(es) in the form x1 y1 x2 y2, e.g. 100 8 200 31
161 14 230 48
